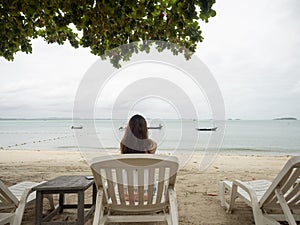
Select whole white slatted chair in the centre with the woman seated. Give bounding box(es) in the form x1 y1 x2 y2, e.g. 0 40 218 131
91 154 178 225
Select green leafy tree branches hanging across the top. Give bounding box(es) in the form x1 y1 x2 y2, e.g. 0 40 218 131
0 0 216 66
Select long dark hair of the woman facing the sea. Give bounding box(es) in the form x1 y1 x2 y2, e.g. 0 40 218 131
120 115 148 154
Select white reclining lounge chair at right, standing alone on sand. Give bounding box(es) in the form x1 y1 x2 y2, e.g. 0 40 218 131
219 156 300 225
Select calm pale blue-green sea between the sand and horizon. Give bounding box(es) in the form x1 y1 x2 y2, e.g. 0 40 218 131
0 120 300 155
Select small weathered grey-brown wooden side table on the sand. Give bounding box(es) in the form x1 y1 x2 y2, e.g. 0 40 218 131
34 176 96 225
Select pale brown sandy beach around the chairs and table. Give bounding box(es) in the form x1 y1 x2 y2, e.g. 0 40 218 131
0 150 289 225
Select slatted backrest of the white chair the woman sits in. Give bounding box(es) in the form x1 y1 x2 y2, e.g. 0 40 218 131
91 154 178 210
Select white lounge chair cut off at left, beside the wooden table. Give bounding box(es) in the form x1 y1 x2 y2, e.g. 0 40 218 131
0 180 54 225
